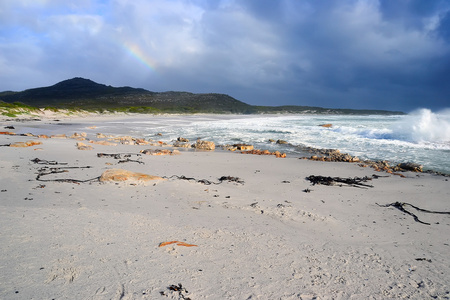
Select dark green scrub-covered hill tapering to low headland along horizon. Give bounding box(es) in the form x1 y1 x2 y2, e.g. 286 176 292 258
0 77 401 114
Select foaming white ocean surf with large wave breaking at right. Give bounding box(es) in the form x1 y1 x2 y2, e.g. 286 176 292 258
17 109 450 174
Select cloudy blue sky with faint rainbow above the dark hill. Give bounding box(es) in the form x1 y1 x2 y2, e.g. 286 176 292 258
0 0 450 112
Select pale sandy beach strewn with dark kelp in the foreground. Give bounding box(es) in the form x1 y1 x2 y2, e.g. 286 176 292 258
0 116 450 300
